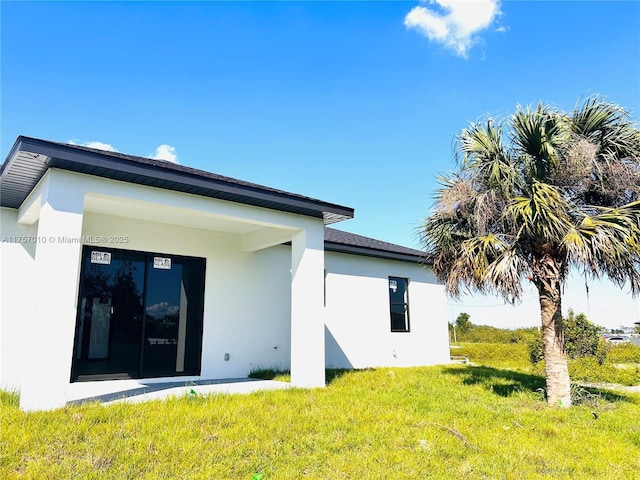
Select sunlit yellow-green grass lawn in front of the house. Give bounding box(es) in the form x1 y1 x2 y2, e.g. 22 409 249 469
0 365 640 480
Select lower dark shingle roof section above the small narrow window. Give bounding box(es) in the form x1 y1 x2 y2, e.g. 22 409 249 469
324 227 428 263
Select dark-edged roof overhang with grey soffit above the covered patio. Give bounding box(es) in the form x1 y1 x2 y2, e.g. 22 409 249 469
0 136 353 225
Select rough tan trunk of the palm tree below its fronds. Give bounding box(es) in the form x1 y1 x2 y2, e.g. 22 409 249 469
538 282 571 407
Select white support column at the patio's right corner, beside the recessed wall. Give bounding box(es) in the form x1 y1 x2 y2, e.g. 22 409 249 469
291 226 325 387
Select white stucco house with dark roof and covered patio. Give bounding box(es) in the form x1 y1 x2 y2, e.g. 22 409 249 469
0 137 449 410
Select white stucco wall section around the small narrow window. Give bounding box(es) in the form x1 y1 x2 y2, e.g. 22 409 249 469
325 253 449 368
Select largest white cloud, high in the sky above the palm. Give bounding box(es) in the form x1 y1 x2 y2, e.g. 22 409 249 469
404 0 503 58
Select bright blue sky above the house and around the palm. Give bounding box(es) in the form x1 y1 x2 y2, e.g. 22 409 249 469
0 0 640 326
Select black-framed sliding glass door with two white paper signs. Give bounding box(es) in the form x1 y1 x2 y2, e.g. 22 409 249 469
71 247 205 381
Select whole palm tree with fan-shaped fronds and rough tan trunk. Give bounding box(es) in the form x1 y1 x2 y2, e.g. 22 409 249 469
421 96 640 407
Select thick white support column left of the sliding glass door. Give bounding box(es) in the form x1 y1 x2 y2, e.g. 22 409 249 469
20 170 84 410
